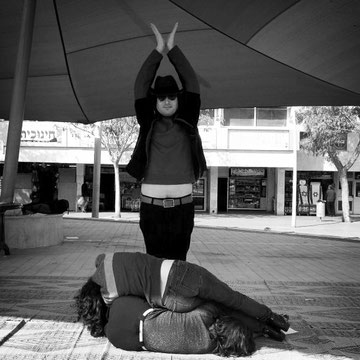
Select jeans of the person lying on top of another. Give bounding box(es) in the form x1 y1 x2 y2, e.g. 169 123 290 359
163 261 272 321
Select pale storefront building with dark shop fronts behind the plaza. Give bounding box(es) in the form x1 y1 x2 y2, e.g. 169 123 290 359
0 107 360 215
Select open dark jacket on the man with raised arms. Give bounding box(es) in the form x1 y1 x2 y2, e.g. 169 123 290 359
126 46 206 181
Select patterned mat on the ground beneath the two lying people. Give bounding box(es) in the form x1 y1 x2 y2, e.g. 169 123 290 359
0 276 360 360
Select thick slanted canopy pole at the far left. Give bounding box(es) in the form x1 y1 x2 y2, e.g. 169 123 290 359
1 0 36 203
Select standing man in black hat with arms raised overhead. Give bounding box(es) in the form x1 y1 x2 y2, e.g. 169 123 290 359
126 23 206 260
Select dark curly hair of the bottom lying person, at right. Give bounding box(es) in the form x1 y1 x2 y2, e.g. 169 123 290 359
209 316 255 357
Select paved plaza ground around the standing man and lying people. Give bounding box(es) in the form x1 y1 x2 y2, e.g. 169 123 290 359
0 214 360 360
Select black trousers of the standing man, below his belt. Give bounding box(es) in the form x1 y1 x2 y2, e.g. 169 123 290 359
140 203 194 260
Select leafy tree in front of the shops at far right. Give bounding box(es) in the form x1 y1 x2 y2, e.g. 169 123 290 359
295 106 360 222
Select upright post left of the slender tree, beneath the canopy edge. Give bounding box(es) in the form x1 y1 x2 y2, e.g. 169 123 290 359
91 124 101 218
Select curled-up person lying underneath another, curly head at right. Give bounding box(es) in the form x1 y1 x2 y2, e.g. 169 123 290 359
81 296 285 356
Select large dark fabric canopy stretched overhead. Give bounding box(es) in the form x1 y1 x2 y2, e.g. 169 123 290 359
0 0 360 123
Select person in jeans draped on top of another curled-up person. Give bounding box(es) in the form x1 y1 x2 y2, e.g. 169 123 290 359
75 252 290 340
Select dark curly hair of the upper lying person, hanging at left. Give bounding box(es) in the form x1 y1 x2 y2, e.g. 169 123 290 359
74 278 108 337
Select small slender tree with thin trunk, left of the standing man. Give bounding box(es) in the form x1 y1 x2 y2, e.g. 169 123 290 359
73 117 139 218
